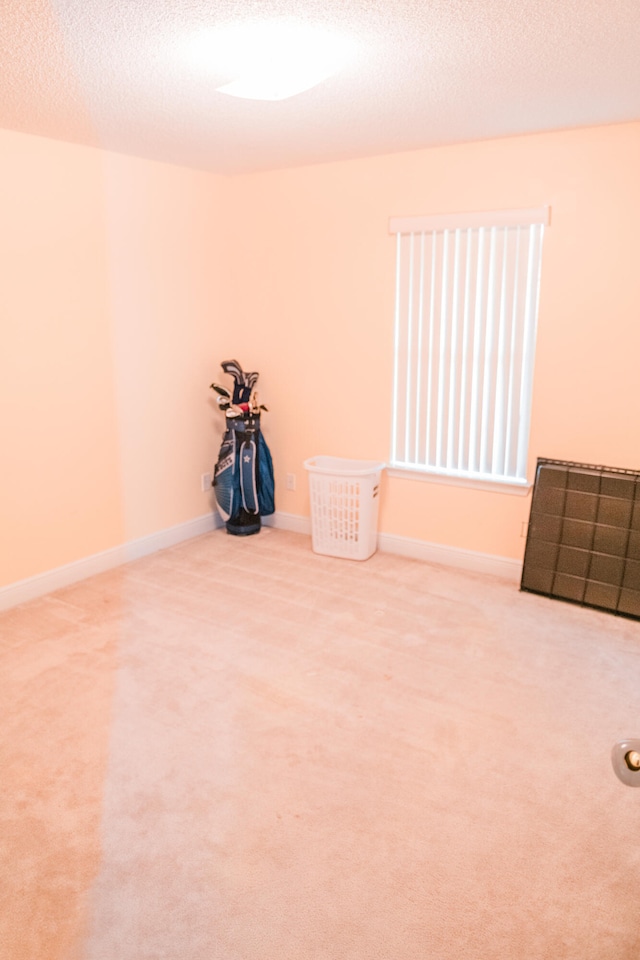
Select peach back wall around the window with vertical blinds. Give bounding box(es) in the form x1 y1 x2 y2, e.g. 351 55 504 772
232 123 640 558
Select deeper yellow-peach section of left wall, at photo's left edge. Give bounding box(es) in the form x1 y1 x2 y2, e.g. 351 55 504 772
0 131 122 583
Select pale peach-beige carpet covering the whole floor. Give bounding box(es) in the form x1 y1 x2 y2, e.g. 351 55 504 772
0 529 640 960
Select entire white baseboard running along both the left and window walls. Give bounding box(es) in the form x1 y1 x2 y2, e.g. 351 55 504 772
0 510 522 610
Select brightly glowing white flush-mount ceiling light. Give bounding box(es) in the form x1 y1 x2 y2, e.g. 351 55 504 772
185 20 354 100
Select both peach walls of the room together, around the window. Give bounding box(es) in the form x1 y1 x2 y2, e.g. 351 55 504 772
0 124 640 585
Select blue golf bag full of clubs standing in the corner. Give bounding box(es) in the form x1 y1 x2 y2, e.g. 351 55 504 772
211 360 275 537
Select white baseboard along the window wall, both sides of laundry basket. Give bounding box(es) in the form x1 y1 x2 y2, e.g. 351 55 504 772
263 511 522 583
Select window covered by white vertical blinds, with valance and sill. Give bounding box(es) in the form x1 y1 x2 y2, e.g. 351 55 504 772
390 208 548 491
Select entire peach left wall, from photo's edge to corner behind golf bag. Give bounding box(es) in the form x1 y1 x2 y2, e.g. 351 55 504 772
0 131 228 585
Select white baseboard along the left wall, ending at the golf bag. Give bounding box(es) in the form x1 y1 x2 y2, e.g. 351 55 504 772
0 513 222 610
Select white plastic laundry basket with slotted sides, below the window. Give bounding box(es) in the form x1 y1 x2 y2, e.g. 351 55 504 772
304 457 385 560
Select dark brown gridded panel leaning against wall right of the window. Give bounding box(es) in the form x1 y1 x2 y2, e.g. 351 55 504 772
520 459 640 619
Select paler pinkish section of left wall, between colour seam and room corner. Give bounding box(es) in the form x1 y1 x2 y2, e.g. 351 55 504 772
104 154 230 540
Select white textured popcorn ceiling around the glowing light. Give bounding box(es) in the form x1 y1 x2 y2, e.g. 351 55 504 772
0 0 640 173
